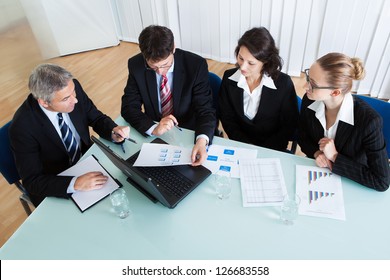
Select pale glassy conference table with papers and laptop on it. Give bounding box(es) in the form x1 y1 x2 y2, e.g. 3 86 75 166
0 118 390 260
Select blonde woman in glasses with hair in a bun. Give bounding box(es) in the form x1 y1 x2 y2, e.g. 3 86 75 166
299 53 390 191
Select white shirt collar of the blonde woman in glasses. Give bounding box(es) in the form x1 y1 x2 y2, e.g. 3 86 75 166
307 92 355 126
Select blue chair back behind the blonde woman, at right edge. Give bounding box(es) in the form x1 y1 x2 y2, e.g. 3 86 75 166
356 95 390 159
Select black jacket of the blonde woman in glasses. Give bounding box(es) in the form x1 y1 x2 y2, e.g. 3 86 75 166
299 95 390 191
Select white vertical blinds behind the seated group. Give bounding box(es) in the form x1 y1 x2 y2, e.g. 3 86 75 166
112 0 390 98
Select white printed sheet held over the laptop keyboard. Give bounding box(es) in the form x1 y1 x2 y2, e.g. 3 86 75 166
134 143 192 166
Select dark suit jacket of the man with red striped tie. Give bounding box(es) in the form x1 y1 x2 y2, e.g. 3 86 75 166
121 49 216 142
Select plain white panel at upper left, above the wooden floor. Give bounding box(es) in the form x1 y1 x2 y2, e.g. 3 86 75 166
21 0 119 58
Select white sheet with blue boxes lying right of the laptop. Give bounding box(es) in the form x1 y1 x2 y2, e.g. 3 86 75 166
203 144 257 178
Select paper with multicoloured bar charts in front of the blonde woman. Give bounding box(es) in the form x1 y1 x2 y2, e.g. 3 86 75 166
296 165 345 220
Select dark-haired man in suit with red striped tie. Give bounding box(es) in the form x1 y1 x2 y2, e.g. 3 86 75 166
122 25 216 165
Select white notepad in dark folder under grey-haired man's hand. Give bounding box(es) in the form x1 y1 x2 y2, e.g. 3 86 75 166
58 155 122 212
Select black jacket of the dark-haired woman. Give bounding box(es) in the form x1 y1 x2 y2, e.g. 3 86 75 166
218 68 299 151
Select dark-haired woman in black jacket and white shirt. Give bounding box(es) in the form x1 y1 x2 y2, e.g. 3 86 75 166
218 27 299 151
